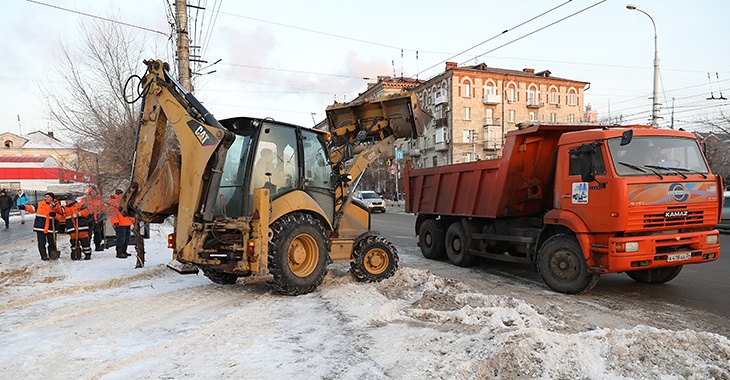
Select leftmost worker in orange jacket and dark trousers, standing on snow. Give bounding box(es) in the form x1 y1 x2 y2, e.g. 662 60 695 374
18 192 63 261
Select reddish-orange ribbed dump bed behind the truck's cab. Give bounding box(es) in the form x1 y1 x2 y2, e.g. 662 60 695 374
404 125 597 218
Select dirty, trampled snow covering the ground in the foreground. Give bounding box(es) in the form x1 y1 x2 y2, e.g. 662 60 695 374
0 229 730 379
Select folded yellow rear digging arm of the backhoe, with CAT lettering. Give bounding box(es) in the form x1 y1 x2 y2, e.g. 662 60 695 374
120 60 234 252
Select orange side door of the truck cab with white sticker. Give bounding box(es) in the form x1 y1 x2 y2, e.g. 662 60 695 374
556 144 611 232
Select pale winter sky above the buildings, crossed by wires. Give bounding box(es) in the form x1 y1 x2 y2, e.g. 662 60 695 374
0 0 730 137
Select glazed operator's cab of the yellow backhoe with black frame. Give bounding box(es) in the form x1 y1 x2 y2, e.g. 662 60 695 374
214 118 334 217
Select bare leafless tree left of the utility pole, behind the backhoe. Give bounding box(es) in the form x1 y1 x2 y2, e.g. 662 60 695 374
41 20 157 191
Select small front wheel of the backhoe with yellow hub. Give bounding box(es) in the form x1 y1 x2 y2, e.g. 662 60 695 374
350 236 398 282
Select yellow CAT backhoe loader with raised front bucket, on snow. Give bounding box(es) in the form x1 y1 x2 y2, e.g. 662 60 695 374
120 60 429 295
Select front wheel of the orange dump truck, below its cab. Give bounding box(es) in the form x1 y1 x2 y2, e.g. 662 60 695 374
537 234 600 294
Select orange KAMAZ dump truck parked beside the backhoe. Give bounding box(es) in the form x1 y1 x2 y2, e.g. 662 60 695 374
404 125 723 294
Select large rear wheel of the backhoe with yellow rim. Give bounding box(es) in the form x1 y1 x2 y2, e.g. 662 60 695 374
269 213 329 296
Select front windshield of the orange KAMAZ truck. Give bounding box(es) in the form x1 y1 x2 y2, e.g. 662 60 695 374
608 136 709 176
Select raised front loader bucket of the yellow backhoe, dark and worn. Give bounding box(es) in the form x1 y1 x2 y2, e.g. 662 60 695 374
326 91 432 146
